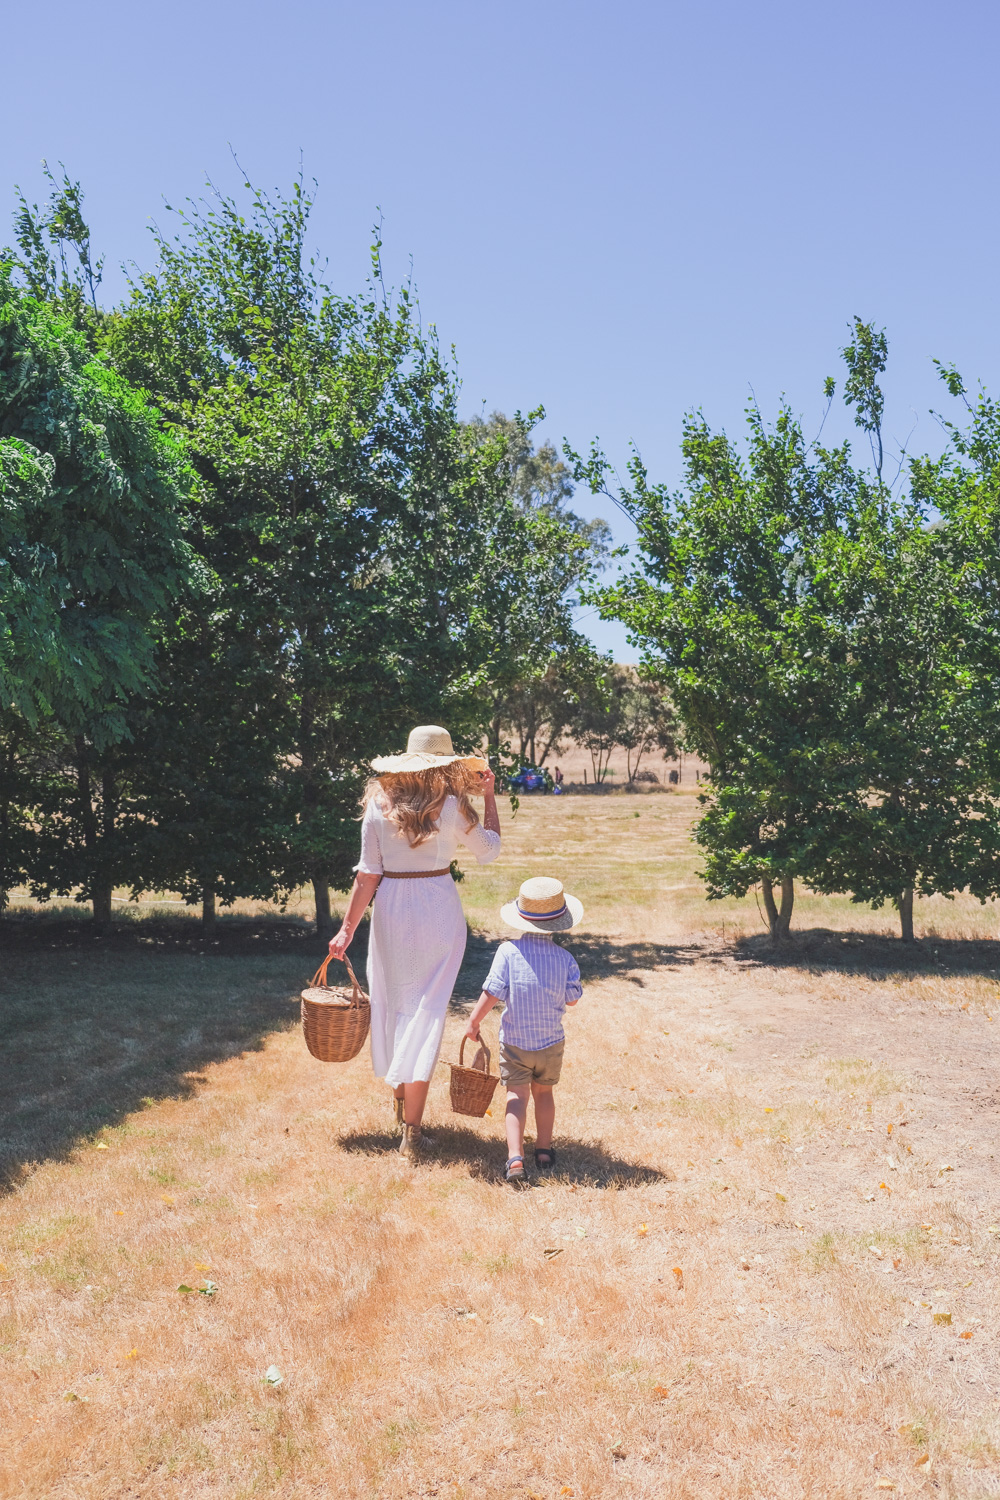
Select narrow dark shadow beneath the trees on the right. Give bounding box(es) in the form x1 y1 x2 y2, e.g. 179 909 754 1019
735 927 1000 980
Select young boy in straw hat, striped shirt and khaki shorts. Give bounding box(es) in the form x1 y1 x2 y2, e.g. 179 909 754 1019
466 876 583 1187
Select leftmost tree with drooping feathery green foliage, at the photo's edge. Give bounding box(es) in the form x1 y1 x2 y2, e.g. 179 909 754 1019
0 274 193 923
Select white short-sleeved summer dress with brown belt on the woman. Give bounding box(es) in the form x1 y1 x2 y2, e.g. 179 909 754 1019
357 797 501 1088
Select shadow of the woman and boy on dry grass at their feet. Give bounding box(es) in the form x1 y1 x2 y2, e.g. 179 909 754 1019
339 1124 675 1191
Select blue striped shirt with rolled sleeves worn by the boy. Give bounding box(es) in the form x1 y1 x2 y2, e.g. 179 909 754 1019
483 933 583 1052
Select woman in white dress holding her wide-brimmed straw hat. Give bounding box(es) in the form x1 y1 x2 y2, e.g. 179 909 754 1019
330 725 499 1163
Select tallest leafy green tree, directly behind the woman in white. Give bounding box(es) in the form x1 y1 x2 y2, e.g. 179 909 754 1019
108 185 554 930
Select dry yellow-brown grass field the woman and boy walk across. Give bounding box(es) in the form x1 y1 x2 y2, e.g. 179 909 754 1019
0 795 1000 1500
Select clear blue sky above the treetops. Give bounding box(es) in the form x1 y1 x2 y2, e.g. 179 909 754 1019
0 0 1000 659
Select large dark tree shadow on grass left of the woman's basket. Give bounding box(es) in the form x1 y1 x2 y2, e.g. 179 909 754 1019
0 948 305 1194
